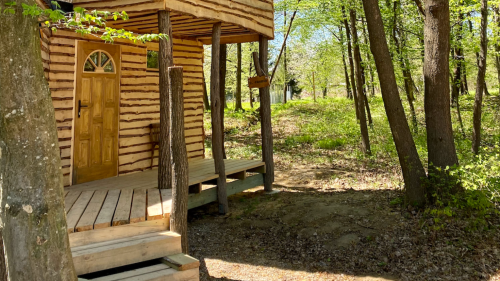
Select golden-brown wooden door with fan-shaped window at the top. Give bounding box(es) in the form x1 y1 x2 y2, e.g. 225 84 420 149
73 41 120 184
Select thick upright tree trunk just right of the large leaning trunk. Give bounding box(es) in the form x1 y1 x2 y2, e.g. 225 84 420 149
424 0 458 190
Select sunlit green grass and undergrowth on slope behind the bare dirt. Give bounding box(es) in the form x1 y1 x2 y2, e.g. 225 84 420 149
205 93 500 182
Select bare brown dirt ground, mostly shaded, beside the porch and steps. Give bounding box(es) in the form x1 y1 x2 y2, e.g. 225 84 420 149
189 166 500 281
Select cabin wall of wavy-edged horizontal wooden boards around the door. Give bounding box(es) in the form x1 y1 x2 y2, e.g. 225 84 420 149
41 30 204 186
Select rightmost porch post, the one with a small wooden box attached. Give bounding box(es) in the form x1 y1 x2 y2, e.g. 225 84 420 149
259 35 274 191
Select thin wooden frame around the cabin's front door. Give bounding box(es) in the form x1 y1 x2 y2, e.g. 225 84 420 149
69 39 122 186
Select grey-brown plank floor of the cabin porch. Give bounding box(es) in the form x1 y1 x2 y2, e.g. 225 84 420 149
64 159 265 233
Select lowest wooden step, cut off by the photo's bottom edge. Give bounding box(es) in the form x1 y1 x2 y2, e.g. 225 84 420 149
81 264 200 281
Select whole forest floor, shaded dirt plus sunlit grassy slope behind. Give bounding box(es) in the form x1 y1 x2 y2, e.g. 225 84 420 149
189 94 500 280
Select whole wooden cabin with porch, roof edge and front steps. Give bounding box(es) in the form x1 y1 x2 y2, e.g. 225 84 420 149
41 0 274 280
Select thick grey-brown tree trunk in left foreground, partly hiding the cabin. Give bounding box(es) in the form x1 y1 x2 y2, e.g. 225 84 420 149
0 0 77 281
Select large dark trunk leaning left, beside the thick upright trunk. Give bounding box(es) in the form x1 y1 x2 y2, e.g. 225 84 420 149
363 0 426 203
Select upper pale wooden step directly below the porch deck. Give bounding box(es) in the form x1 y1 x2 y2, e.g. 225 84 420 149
71 231 182 275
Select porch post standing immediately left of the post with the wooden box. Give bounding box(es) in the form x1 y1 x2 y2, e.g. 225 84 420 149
210 22 228 214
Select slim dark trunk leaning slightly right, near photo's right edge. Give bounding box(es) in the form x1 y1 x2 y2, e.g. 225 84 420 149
472 0 488 154
